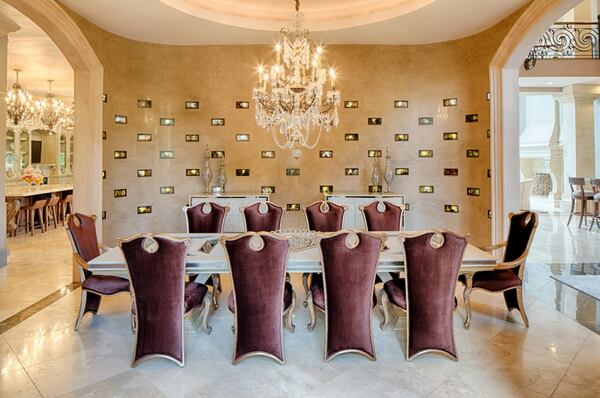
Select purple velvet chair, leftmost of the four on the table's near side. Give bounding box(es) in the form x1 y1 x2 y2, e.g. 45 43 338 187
119 235 211 367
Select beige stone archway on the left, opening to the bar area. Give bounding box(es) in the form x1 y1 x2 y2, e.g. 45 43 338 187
2 0 104 237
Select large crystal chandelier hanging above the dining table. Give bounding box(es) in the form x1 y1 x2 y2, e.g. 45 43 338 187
252 0 340 158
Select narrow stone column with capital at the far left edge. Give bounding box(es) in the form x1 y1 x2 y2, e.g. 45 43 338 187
0 18 19 267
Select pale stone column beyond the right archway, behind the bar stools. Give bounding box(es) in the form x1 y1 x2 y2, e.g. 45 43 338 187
558 84 600 204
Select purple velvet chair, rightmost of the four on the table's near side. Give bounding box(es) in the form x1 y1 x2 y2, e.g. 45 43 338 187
380 231 468 361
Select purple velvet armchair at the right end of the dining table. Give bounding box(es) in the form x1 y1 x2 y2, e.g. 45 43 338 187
459 211 538 328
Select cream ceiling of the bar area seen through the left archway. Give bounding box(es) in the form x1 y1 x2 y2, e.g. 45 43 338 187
0 2 74 98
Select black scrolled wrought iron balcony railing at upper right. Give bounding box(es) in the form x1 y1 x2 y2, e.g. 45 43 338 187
524 16 600 70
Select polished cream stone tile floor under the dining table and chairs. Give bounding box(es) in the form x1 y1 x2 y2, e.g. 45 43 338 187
0 215 600 398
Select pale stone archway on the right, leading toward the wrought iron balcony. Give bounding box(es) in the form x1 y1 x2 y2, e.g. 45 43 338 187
490 0 581 241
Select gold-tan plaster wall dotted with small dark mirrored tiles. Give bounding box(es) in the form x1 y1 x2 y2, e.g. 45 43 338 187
68 8 516 244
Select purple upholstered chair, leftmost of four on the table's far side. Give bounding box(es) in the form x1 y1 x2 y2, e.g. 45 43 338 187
183 202 229 311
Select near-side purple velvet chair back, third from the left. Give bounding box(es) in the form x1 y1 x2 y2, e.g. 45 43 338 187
320 231 383 361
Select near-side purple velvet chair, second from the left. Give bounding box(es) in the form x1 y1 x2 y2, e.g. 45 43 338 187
221 232 296 365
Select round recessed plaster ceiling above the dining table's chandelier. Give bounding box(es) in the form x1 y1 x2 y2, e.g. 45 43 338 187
61 0 529 44
